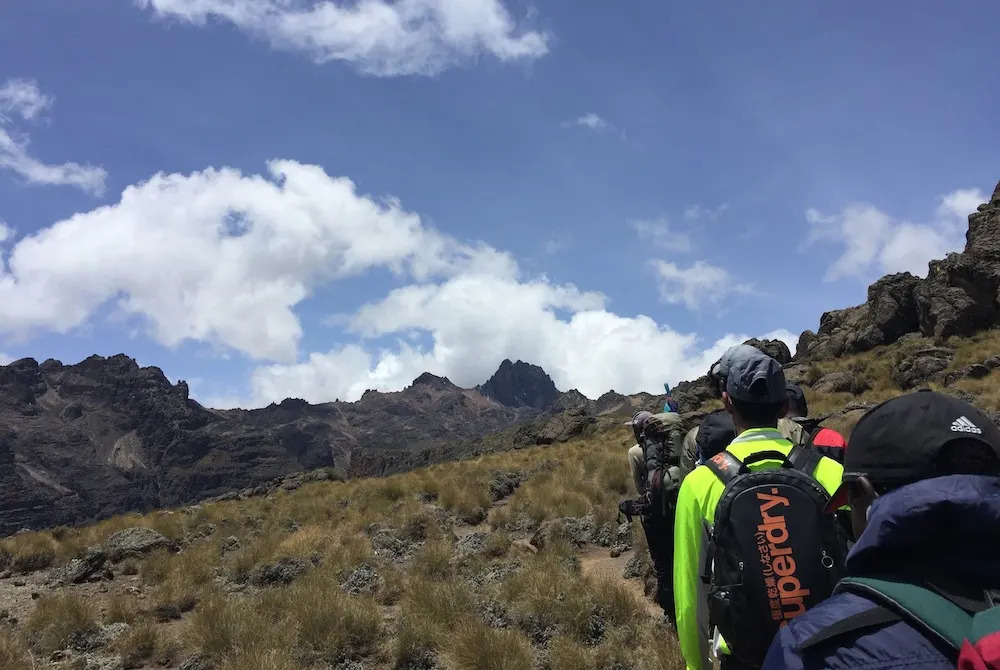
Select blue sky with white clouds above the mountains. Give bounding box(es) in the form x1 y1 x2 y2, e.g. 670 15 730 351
0 0 1000 406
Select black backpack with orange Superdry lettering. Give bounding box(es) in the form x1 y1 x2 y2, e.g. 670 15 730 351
703 445 847 667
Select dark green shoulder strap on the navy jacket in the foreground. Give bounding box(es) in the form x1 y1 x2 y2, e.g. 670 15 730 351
834 577 972 651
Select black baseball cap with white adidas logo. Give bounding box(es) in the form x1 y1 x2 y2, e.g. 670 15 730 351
827 389 1000 511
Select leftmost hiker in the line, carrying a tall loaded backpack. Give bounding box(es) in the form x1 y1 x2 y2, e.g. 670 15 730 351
619 411 683 624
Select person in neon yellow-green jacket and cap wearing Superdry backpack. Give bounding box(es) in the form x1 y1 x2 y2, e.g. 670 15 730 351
674 347 846 670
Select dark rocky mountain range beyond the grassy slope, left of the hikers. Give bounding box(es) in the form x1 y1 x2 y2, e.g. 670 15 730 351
0 355 552 536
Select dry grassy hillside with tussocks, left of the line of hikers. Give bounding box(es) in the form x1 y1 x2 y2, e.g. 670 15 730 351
0 430 681 670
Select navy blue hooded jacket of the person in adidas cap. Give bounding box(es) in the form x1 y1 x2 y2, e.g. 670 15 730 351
764 475 1000 670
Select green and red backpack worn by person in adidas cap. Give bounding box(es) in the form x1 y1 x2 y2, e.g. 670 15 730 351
799 577 1000 670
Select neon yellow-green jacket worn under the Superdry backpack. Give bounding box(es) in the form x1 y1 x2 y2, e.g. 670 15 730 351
674 428 844 670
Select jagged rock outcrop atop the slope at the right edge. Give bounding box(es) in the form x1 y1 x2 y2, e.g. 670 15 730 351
796 184 1000 360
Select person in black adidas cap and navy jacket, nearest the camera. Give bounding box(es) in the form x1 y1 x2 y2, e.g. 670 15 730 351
764 390 1000 670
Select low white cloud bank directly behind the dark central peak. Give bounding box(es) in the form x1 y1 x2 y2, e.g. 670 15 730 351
252 275 780 404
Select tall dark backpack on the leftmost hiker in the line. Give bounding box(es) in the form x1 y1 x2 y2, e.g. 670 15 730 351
641 412 685 517
